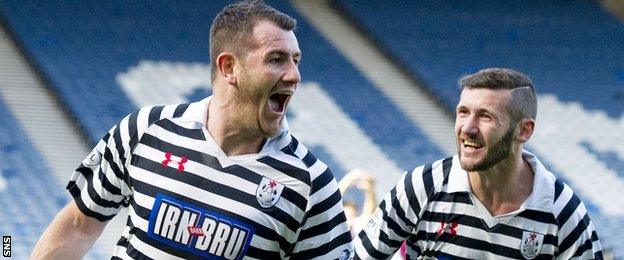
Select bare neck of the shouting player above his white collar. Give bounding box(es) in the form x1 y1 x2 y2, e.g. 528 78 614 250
206 97 266 156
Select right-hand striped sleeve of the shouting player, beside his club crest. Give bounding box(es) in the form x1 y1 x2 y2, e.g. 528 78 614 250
290 160 353 259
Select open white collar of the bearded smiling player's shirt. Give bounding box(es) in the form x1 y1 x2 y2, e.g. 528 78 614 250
448 150 556 212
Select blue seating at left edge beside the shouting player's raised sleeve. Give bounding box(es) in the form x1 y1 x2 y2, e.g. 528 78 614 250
0 99 103 259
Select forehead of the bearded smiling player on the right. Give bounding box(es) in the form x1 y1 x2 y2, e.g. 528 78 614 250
457 88 511 110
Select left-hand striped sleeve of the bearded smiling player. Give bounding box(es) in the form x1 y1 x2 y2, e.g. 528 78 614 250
353 167 427 259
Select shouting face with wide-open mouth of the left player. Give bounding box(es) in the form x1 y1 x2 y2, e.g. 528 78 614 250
237 21 301 137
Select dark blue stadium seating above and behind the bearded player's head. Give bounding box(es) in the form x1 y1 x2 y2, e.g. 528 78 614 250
334 0 624 118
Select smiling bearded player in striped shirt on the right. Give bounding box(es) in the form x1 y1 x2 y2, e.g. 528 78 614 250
354 69 602 259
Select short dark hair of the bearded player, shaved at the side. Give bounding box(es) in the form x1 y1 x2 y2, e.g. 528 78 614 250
459 68 537 124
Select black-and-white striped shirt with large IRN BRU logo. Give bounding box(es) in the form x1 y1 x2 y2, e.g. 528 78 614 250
67 97 353 259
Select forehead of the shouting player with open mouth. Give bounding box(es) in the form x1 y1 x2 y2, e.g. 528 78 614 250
252 21 301 54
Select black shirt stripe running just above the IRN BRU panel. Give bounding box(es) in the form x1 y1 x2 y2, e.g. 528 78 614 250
132 155 301 232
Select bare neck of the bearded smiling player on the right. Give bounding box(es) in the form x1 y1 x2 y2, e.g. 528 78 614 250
468 149 534 216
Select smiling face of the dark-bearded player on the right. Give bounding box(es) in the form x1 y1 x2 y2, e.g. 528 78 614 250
455 88 515 171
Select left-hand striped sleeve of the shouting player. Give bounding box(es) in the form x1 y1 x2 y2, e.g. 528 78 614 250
67 104 176 221
